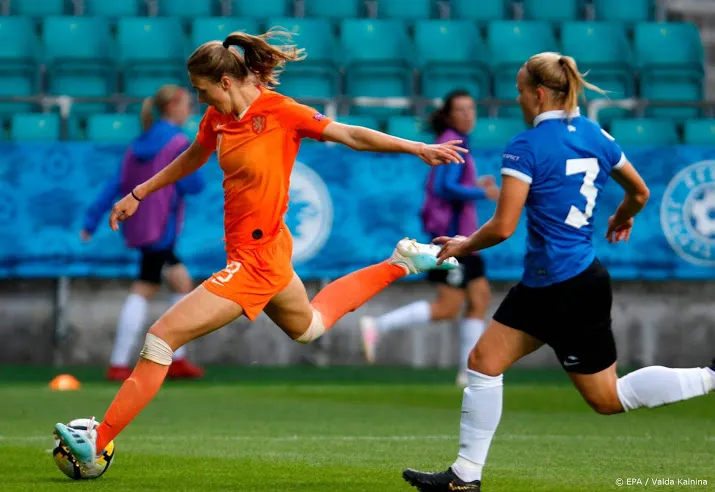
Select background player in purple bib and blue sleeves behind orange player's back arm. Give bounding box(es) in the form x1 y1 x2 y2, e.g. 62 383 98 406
81 85 204 381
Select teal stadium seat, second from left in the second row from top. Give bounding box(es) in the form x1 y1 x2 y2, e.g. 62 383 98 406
42 16 115 113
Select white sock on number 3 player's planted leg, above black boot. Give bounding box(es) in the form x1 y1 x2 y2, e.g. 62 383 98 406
452 369 504 482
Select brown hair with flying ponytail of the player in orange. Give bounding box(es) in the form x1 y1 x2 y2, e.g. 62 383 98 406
186 28 305 87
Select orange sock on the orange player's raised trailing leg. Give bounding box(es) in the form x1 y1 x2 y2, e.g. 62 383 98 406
311 260 407 330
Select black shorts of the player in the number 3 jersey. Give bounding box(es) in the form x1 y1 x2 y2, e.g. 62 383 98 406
494 260 617 374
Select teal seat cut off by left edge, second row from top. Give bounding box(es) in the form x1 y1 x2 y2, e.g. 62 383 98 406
0 17 38 114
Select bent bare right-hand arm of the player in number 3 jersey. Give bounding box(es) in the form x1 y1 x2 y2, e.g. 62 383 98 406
606 162 650 243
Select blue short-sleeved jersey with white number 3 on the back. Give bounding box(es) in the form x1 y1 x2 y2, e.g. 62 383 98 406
501 111 626 287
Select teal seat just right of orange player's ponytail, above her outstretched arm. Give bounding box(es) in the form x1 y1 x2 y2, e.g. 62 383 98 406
340 19 414 114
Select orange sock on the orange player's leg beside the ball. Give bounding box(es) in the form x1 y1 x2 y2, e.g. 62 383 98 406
97 359 169 452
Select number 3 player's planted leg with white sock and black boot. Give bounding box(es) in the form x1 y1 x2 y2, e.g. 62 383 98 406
402 321 543 492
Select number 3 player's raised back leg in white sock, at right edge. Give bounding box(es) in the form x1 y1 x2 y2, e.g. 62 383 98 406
569 361 715 415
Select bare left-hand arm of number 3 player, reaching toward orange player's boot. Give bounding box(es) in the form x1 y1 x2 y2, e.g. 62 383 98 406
434 175 530 264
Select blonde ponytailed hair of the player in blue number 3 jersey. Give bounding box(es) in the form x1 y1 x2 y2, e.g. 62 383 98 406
524 51 606 112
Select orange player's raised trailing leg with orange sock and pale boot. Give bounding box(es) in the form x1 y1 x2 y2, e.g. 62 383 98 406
265 239 458 343
